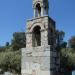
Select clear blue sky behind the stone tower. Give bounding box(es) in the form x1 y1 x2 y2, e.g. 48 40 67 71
0 0 75 46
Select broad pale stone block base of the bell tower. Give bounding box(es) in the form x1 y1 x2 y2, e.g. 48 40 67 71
21 45 57 75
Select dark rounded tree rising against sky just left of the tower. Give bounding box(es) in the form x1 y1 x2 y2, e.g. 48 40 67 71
11 32 26 50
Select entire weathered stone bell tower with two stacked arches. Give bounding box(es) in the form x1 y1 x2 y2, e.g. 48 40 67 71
21 0 60 75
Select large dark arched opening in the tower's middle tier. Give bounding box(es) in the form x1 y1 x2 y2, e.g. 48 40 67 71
32 26 41 47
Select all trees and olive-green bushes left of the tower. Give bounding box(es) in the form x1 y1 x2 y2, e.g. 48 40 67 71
0 32 26 74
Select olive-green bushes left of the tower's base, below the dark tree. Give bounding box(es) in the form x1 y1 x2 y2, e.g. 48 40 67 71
0 50 21 73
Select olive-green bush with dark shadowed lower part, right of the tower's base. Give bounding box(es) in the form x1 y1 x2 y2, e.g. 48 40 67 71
61 48 75 70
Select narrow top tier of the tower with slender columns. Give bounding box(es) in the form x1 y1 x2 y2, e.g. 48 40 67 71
33 0 49 17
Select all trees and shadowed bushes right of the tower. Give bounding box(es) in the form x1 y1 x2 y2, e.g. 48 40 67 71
56 31 75 71
